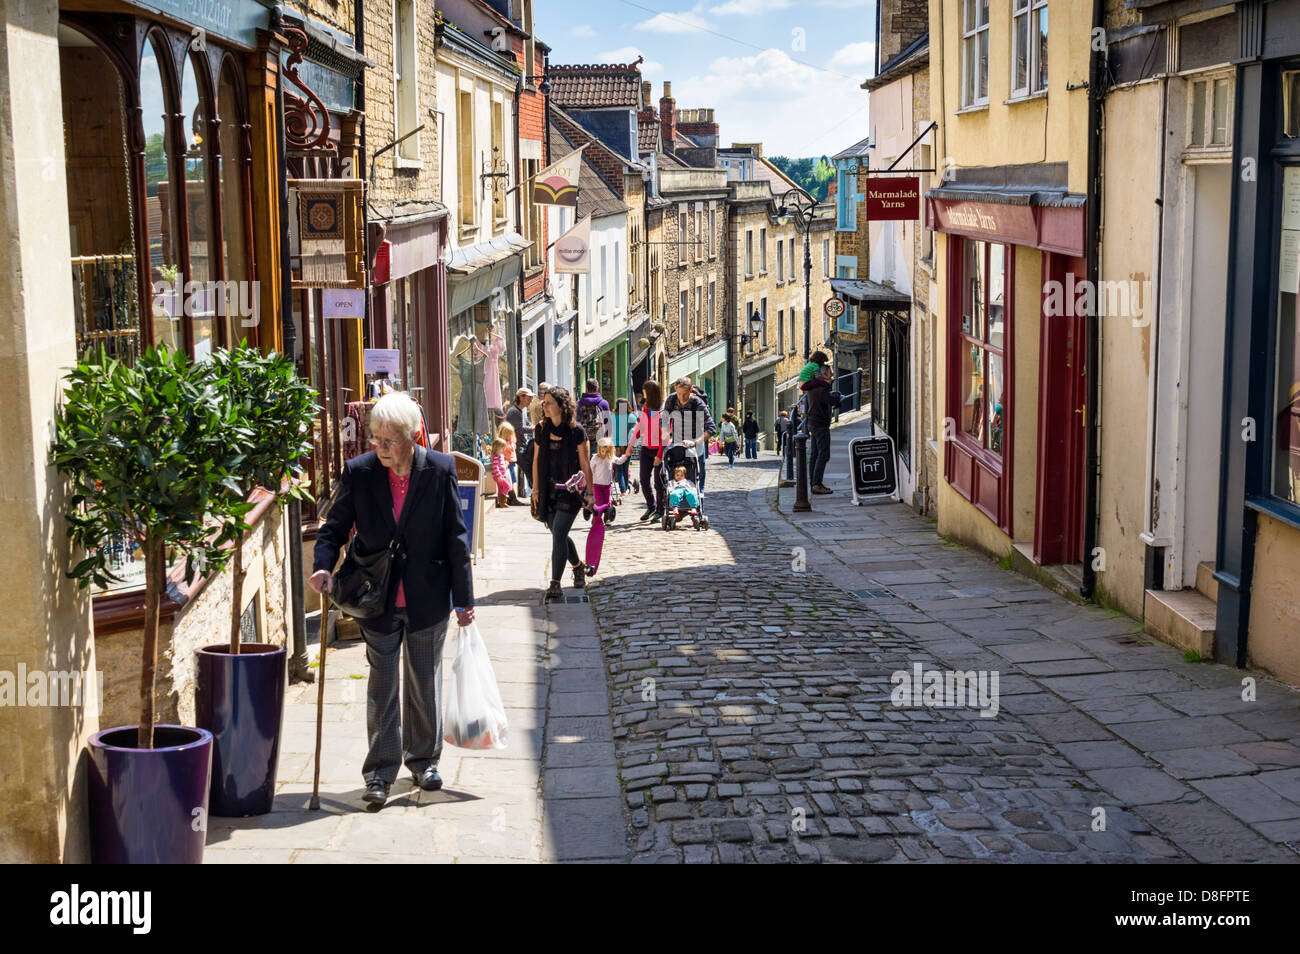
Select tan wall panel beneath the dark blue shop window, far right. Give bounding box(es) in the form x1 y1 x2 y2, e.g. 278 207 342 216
1247 513 1300 686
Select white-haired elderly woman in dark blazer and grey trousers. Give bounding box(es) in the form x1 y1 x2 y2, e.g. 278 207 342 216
311 394 475 806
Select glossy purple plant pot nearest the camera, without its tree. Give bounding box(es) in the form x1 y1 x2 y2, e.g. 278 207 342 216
87 725 212 864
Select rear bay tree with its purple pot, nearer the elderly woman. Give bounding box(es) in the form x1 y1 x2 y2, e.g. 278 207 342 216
195 344 317 818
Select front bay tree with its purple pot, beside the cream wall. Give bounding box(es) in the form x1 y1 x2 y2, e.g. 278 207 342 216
51 346 252 863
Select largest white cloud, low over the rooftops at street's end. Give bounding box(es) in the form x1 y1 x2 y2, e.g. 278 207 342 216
673 43 875 156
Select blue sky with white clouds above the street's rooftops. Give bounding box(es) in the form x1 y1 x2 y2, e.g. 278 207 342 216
534 0 875 156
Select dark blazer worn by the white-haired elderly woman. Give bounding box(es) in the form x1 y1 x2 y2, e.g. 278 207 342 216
312 446 475 630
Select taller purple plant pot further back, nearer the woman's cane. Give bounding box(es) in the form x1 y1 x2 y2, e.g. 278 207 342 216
195 642 286 818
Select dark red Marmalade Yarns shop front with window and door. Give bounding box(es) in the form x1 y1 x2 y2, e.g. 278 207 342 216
925 183 1084 564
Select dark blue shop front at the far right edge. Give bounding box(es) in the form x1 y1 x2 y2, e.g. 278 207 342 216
1214 13 1300 684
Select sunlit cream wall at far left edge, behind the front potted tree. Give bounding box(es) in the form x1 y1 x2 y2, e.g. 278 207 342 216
0 0 99 863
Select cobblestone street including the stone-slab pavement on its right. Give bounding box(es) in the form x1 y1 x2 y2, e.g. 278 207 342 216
589 425 1300 862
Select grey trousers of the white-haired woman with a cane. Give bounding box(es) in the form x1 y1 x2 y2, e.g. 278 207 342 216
361 610 447 785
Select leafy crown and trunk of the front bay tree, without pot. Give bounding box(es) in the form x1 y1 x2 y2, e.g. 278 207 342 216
49 346 254 749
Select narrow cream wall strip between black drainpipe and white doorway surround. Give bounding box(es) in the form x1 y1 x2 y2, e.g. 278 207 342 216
1097 83 1164 617
